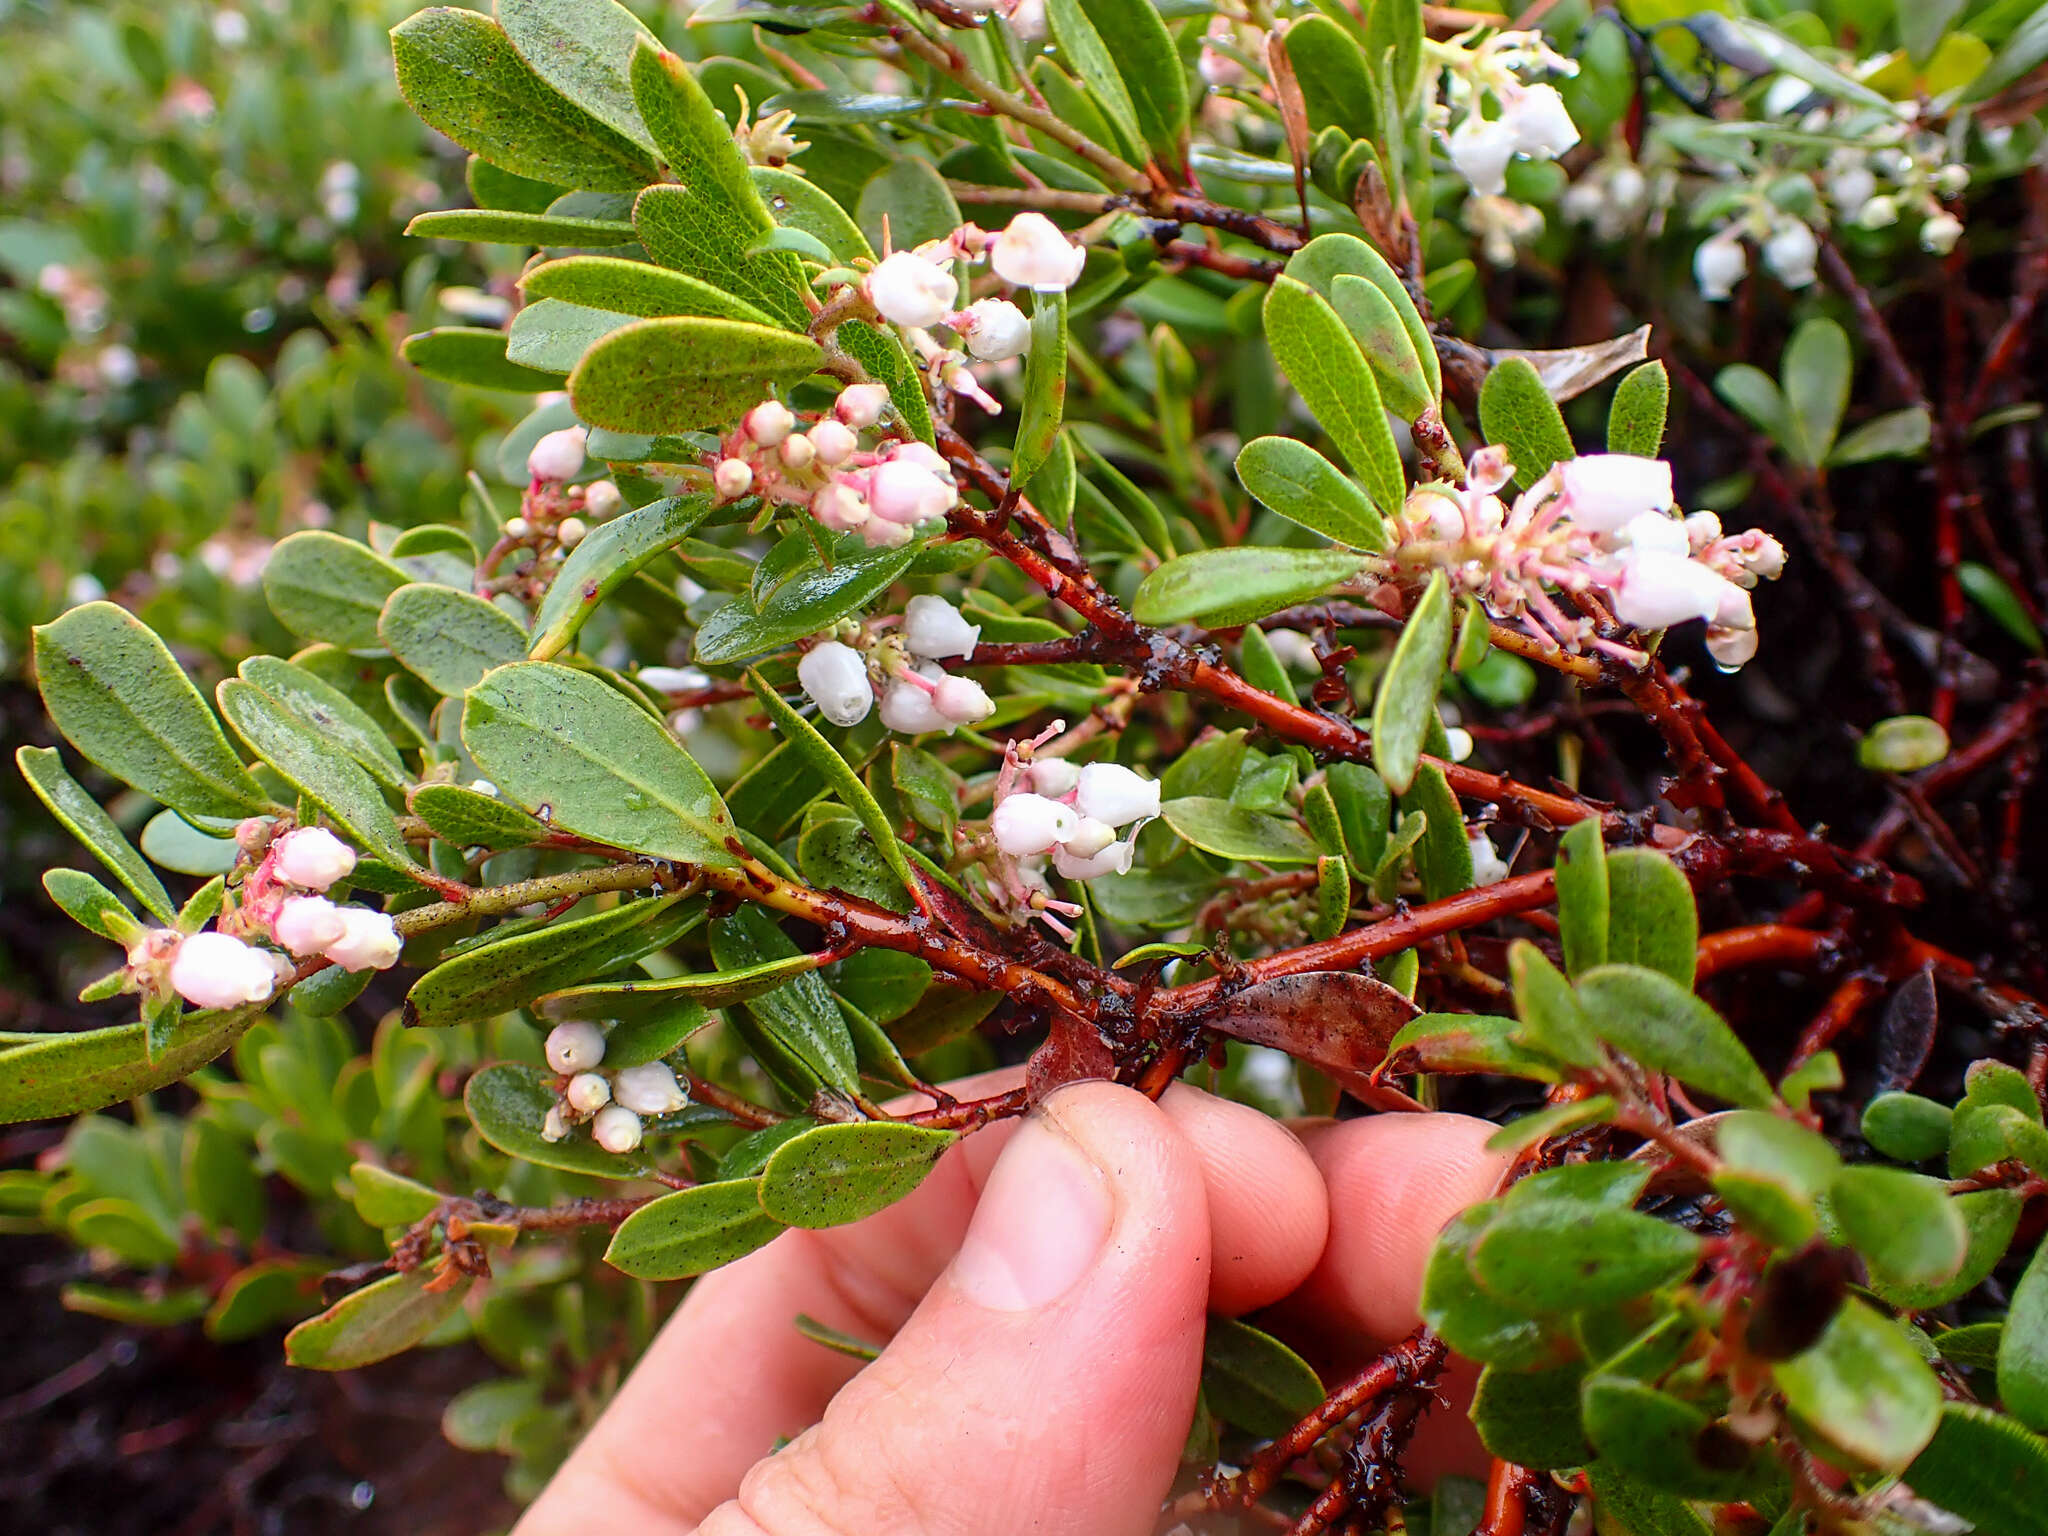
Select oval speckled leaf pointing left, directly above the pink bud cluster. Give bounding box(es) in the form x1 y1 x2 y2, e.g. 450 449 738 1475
569 315 823 434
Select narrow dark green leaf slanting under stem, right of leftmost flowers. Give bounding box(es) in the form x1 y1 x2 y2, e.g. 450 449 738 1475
406 895 694 1028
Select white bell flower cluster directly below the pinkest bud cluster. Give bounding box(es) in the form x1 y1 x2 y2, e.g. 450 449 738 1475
797 596 995 735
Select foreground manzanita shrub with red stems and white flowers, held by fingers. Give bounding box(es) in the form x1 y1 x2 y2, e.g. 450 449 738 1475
0 0 2048 1536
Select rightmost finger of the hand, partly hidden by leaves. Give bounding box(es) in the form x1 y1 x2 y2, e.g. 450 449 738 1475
1266 1114 1509 1487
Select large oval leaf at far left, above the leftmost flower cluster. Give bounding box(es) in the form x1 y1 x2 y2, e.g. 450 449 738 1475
25 602 270 823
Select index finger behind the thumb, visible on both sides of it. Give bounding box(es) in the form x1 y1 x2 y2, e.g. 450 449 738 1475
518 1073 1327 1536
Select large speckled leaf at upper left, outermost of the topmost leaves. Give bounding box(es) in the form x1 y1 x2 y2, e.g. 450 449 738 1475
391 6 655 193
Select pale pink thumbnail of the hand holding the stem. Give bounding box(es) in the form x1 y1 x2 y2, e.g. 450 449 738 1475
952 1114 1114 1313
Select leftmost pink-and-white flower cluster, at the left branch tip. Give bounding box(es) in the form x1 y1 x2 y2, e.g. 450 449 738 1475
127 831 401 1008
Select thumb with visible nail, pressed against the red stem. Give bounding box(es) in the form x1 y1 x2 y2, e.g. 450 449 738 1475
698 1083 1210 1536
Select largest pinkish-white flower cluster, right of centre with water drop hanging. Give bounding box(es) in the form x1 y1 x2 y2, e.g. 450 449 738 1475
1395 446 1784 670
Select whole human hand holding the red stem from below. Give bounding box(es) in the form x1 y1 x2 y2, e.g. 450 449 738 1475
514 1081 1501 1536
